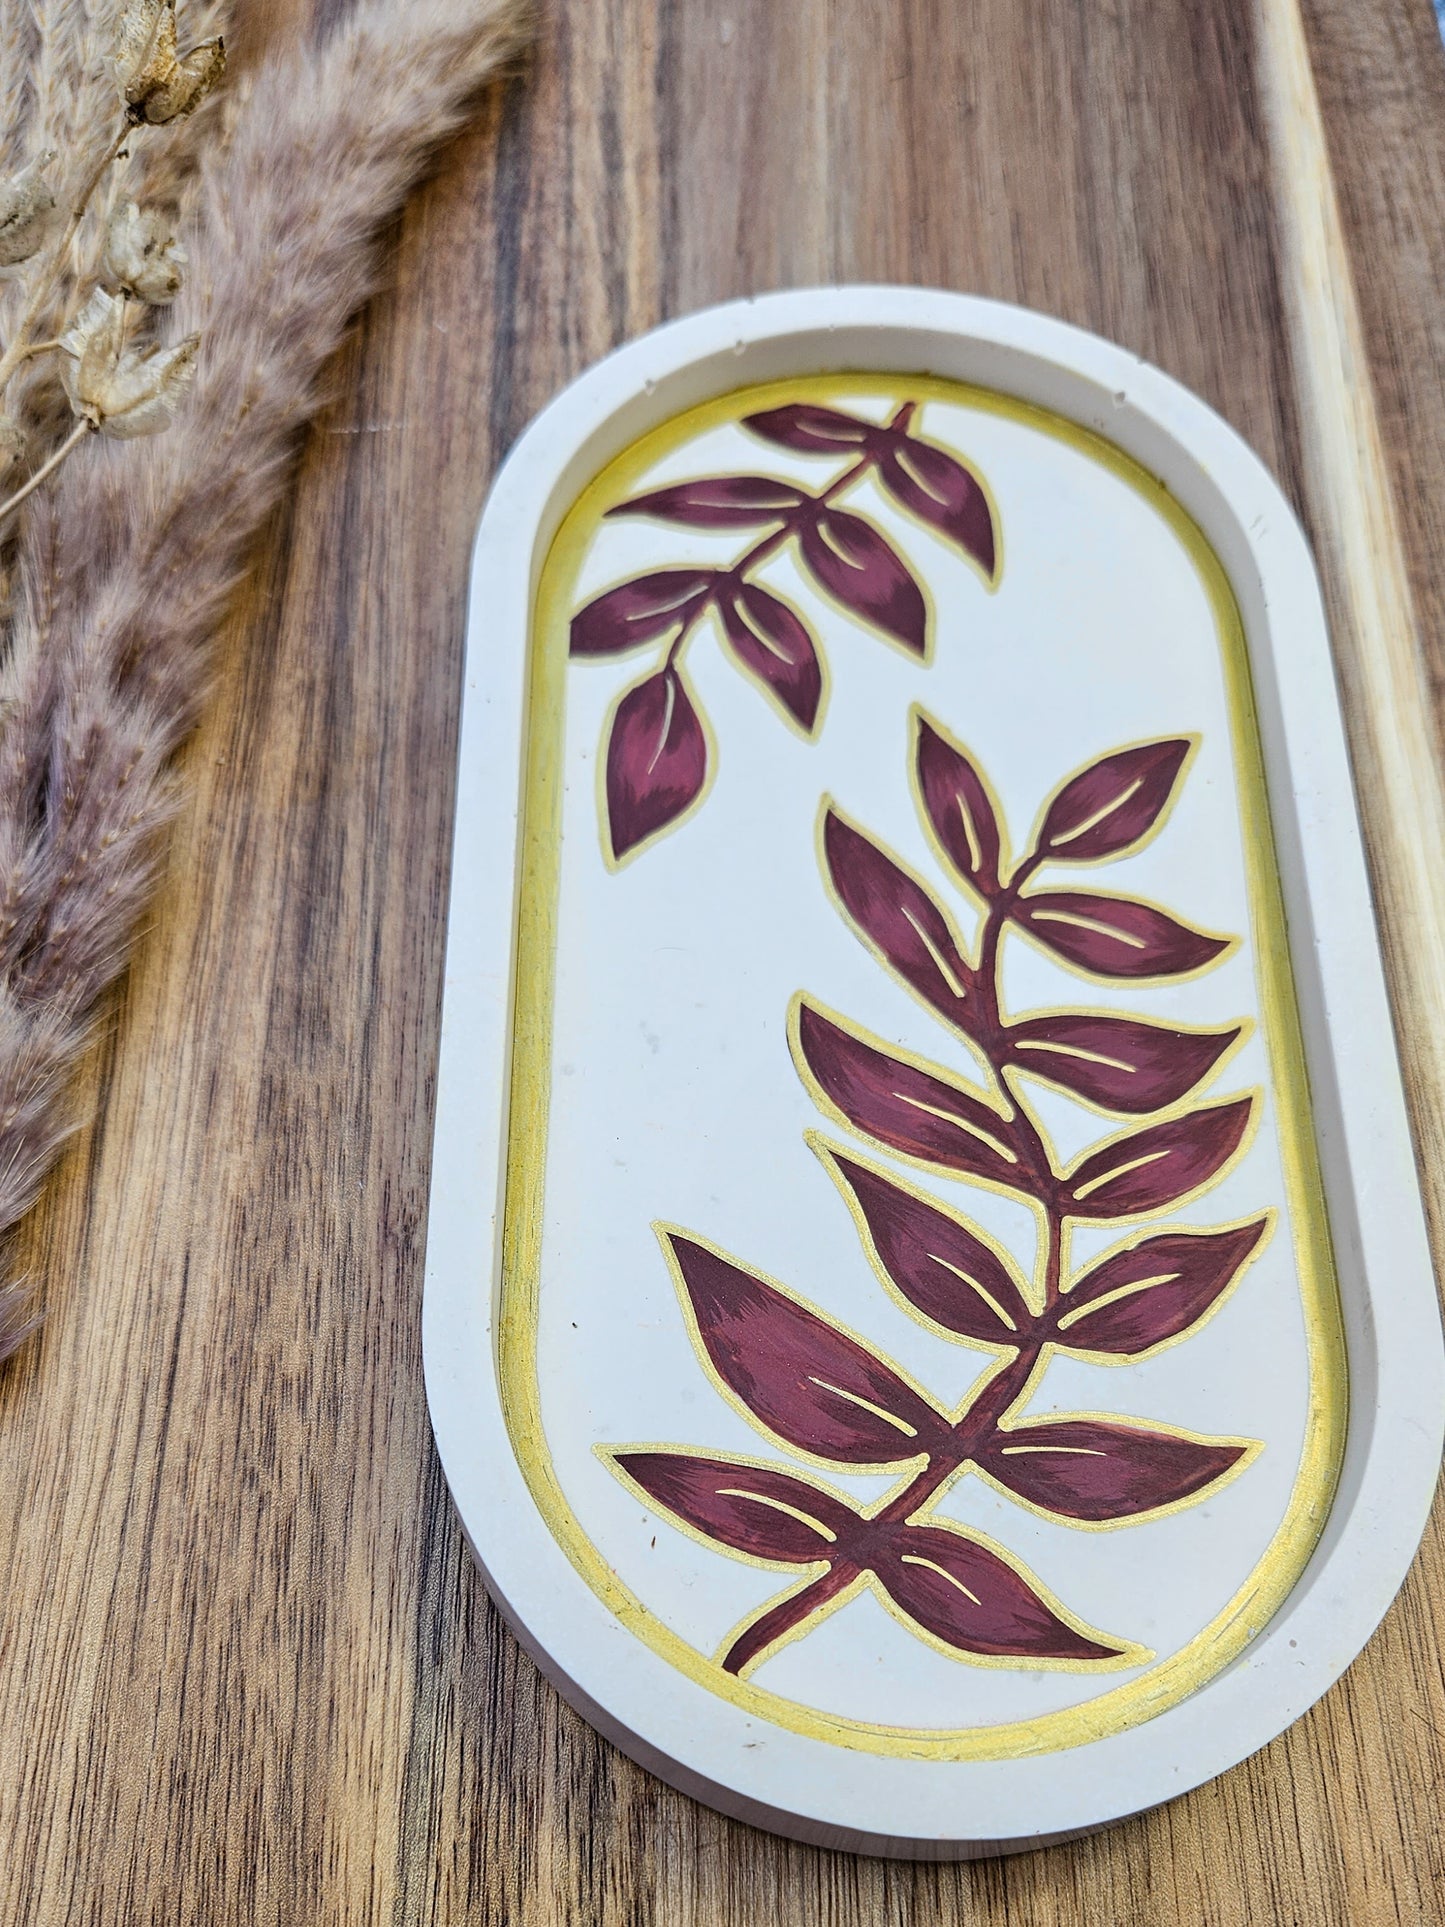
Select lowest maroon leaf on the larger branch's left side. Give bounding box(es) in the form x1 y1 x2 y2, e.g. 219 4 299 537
615 1451 859 1565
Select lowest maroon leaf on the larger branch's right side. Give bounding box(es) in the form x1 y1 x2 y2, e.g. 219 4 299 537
873 1526 1125 1659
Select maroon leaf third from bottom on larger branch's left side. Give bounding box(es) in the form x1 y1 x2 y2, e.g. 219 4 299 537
832 1150 1033 1345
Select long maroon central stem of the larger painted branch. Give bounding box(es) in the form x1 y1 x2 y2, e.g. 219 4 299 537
723 882 1064 1673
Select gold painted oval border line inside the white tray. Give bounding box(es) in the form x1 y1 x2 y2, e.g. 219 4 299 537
497 376 1349 1759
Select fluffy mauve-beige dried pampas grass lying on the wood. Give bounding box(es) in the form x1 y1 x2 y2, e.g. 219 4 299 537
0 0 526 1357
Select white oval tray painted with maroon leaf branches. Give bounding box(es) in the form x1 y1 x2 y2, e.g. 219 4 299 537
426 287 1445 1856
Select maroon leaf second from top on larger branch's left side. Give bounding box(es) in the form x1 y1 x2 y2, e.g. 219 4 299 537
823 809 973 1031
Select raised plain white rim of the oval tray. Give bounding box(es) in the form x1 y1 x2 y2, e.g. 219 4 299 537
422 285 1445 1858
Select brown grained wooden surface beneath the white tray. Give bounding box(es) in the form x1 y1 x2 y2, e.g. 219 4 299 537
0 0 1445 1927
